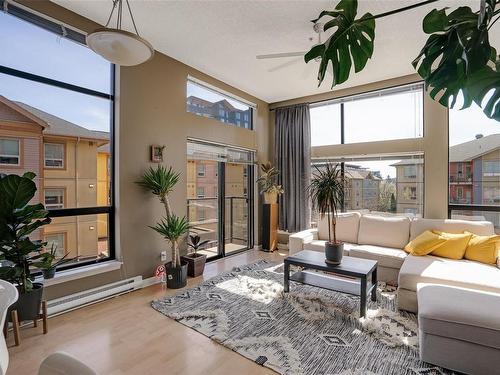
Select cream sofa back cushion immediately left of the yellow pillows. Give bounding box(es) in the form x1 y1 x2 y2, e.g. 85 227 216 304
358 215 410 249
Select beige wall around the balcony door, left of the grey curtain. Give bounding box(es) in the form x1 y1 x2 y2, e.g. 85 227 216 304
16 0 272 299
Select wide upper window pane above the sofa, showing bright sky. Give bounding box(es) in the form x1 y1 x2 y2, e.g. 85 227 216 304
310 84 423 147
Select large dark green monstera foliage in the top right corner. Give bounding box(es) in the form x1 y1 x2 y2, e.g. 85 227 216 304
412 0 500 120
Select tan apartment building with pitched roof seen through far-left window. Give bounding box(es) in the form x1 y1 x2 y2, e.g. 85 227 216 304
0 96 110 259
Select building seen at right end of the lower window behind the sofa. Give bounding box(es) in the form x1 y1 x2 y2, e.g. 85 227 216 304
391 159 424 216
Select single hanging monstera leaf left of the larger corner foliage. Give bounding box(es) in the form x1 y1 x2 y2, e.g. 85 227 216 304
304 0 375 87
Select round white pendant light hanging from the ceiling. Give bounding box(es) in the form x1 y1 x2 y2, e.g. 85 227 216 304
87 0 154 66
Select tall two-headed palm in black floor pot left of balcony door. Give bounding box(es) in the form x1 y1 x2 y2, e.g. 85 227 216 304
137 165 189 288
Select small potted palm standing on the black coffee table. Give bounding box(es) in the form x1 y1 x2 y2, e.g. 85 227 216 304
308 163 345 265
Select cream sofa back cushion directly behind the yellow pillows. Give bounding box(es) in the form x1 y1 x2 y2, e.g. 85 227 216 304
410 219 495 240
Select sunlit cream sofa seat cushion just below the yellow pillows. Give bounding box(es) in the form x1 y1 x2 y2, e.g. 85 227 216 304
398 255 500 293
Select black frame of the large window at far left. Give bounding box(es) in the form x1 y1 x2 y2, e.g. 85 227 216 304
0 4 116 274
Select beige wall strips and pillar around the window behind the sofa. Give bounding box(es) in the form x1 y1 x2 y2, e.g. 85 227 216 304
269 75 448 218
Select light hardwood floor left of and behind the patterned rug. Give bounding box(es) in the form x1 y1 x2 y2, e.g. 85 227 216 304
7 250 286 375
